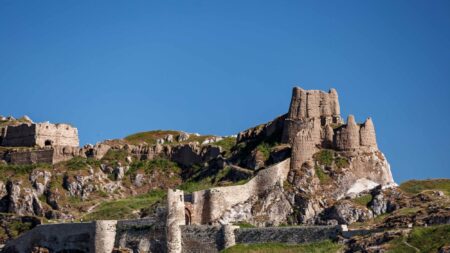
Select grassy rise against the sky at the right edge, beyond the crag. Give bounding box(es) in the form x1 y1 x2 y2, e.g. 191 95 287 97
400 179 450 196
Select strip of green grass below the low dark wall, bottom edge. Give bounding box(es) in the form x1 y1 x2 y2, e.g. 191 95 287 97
222 241 342 253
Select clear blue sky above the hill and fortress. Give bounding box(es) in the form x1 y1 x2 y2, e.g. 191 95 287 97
0 0 450 182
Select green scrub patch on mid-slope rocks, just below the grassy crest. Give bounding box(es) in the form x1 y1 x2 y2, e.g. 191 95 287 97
126 158 181 175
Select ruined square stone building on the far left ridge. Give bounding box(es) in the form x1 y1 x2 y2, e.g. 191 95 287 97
0 122 79 147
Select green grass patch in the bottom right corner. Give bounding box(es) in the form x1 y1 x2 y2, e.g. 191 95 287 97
388 225 450 253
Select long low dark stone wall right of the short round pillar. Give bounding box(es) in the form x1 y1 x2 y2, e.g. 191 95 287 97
235 226 340 244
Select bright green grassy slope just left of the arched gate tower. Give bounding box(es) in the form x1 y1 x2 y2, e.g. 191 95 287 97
84 190 166 220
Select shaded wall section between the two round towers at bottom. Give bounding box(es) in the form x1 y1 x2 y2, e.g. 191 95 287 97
114 219 167 253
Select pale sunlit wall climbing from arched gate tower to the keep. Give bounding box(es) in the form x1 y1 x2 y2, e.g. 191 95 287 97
191 159 290 224
